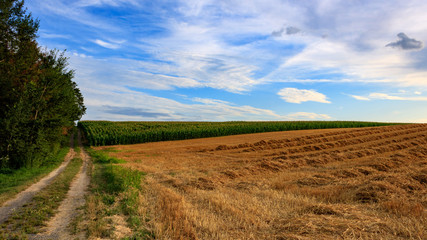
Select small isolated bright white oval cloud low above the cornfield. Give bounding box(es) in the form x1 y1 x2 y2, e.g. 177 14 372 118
277 88 331 103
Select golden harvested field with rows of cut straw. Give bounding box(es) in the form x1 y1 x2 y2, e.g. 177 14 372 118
96 124 427 239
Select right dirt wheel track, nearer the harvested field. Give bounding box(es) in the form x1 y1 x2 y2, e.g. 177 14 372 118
31 131 90 239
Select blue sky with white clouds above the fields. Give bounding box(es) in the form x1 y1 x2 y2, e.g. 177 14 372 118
26 0 427 122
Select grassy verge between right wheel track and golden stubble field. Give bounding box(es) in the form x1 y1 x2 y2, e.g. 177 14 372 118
86 149 154 239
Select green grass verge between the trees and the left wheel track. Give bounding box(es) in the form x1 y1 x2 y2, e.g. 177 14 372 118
0 147 70 205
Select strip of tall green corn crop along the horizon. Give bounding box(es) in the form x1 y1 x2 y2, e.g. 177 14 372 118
78 121 402 146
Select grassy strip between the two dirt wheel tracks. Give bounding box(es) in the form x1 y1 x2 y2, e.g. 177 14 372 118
0 158 82 239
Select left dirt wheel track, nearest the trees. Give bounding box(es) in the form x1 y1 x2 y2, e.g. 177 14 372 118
0 135 76 224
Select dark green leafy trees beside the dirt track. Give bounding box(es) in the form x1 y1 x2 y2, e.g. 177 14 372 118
0 0 86 169
